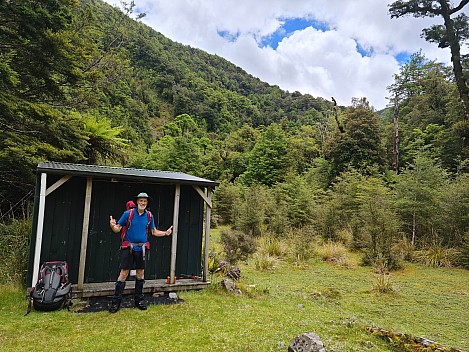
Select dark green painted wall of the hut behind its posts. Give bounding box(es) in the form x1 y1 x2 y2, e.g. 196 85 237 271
27 175 204 286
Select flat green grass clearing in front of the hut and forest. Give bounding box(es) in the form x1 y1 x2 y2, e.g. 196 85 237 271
0 233 469 352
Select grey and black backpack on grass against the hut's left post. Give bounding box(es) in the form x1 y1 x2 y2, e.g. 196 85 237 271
26 261 72 315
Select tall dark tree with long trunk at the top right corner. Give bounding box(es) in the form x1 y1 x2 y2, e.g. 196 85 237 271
389 0 469 121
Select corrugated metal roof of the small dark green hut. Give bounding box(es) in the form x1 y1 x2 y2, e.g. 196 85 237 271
37 162 219 187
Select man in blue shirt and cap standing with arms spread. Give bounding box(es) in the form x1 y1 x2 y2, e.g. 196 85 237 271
109 193 173 313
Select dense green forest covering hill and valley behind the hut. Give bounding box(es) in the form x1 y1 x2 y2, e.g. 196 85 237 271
0 0 469 281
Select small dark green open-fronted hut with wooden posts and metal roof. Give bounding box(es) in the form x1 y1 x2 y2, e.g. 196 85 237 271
27 162 218 297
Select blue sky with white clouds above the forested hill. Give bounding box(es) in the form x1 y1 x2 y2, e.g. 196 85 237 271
101 0 469 110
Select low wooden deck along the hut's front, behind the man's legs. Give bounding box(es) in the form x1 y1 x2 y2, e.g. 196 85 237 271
72 279 210 298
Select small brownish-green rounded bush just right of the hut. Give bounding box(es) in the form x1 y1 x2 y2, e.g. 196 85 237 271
221 230 256 264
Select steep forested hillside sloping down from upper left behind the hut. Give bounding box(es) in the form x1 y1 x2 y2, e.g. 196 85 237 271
0 0 331 212
